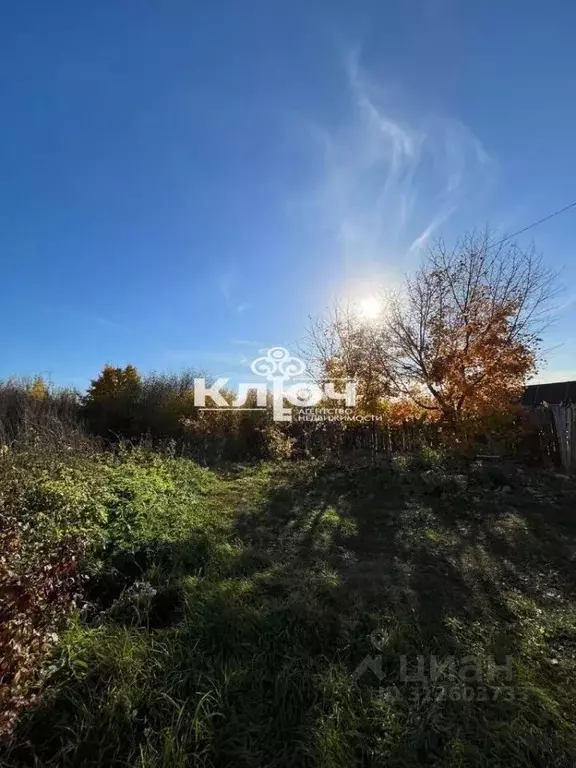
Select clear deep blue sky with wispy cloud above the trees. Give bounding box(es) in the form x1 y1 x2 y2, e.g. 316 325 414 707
0 0 576 387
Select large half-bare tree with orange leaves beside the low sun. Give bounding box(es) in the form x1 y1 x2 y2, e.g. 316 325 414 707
308 232 555 422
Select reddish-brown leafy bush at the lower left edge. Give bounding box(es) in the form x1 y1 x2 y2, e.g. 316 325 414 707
0 510 80 739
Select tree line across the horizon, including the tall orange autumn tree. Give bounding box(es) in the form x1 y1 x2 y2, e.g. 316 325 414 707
0 231 557 462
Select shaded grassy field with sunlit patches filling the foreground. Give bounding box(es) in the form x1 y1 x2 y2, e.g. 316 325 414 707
2 455 576 768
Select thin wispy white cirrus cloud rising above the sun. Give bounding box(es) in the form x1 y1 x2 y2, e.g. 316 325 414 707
294 47 497 280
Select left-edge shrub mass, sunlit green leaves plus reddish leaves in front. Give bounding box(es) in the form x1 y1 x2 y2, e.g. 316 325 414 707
0 449 223 737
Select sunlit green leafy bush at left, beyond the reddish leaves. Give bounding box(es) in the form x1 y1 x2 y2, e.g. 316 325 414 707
0 448 219 557
